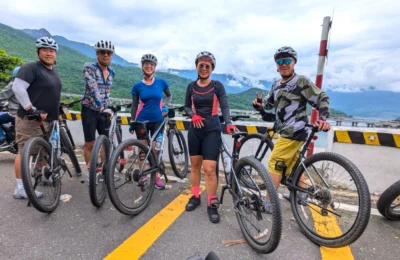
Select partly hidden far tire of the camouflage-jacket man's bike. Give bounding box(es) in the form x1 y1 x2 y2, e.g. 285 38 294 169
237 133 274 190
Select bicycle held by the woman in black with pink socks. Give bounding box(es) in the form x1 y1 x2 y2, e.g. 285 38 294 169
217 115 282 254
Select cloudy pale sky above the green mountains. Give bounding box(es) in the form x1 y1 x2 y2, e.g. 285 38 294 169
0 0 400 92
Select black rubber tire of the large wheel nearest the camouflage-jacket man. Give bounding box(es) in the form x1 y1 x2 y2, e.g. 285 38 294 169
290 152 371 248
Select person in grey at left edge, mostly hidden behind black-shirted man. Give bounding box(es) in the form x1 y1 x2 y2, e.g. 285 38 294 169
0 66 20 146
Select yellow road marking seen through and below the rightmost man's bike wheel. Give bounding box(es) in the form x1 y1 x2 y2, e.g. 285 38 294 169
309 205 354 260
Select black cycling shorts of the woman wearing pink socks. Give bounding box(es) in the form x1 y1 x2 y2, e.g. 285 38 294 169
188 127 221 161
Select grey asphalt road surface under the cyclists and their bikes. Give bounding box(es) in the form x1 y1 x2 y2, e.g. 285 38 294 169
0 153 400 260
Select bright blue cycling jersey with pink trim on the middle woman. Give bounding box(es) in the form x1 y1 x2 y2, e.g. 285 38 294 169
131 78 169 122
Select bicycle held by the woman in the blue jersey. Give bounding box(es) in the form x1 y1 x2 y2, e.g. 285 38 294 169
106 107 189 215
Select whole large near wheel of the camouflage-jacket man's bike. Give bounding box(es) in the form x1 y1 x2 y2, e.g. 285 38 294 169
290 152 371 247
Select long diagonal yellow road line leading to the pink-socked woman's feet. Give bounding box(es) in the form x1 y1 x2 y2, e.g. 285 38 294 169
104 186 205 260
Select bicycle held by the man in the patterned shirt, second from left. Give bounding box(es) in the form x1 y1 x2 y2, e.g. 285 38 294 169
89 103 131 207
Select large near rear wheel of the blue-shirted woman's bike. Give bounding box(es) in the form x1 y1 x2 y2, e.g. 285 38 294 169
106 139 157 215
